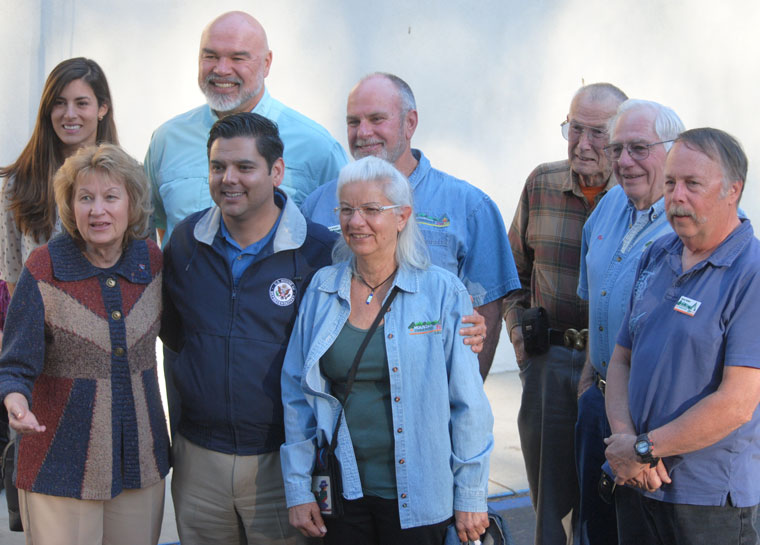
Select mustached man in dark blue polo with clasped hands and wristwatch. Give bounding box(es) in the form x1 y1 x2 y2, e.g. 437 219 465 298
605 129 760 545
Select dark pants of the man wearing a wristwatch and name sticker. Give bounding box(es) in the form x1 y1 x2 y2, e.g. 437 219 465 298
641 496 760 545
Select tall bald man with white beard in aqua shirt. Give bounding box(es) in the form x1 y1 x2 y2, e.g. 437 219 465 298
145 12 347 244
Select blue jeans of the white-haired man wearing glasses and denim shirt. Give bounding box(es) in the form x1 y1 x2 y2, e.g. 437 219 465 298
575 385 617 545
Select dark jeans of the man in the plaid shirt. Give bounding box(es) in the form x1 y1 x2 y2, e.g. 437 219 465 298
517 346 586 545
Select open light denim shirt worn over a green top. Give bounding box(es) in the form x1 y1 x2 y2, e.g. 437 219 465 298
280 262 493 528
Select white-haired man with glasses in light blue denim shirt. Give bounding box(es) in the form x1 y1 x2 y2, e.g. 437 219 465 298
575 99 684 545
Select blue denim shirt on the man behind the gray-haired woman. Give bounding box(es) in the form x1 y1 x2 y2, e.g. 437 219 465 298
301 149 520 307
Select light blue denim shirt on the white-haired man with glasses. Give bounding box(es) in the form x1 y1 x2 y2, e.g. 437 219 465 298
578 185 673 377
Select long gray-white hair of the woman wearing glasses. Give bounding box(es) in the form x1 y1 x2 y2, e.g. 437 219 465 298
332 156 430 269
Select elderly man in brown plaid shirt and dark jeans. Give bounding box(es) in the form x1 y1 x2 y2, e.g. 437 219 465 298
504 83 627 545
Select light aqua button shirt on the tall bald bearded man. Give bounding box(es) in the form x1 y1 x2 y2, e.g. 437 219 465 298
145 91 348 240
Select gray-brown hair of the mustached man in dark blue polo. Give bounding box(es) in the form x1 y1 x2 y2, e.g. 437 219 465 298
676 127 749 202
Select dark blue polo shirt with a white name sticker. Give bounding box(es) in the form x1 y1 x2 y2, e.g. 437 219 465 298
618 220 760 507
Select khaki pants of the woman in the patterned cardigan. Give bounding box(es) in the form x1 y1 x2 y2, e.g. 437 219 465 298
18 480 165 545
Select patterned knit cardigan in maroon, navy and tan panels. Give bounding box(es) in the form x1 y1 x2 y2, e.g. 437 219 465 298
0 233 169 500
